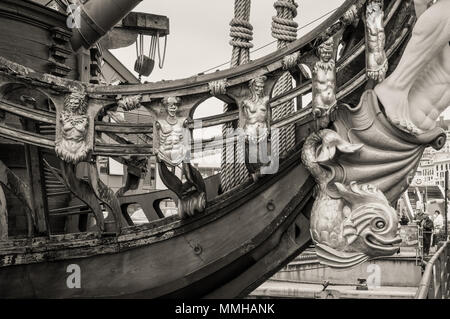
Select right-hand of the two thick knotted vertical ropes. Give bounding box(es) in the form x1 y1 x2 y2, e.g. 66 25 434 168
272 0 298 156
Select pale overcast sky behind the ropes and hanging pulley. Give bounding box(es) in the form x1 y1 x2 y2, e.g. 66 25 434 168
112 0 344 168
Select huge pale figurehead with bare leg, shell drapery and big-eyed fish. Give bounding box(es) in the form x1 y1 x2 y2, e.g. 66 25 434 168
302 0 450 267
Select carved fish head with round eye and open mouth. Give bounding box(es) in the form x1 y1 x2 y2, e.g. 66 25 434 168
336 182 402 257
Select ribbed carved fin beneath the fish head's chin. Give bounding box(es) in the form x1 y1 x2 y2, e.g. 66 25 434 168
316 243 369 268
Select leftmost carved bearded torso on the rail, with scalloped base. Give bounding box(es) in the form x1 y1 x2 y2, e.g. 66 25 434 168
55 92 92 164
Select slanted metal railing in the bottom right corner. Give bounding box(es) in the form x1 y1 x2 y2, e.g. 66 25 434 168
415 240 450 299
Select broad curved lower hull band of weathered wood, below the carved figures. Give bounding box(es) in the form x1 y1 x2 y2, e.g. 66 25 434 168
0 146 314 298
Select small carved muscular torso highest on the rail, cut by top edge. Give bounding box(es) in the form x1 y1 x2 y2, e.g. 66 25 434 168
366 0 389 82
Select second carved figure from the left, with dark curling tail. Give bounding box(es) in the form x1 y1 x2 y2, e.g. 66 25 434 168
155 97 206 218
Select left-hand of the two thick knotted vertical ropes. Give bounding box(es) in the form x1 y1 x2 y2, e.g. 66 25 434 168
220 0 253 191
